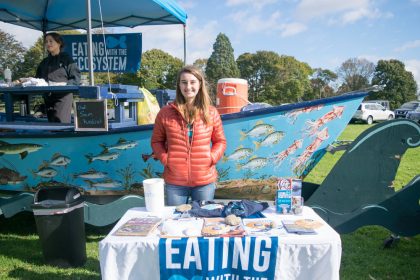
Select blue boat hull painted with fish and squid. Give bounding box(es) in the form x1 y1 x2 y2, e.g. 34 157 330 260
0 92 367 199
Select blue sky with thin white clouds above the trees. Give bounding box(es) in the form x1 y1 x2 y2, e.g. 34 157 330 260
0 0 420 88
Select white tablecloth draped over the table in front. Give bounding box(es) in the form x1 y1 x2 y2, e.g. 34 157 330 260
99 207 341 280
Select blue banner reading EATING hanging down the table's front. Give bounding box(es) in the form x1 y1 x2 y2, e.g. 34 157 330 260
159 236 278 280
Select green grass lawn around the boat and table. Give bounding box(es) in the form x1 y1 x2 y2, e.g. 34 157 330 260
0 124 420 280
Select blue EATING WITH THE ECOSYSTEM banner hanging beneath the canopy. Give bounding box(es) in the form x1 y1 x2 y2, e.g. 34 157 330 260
63 33 142 73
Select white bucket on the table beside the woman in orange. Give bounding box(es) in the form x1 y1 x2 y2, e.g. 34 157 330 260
143 178 165 212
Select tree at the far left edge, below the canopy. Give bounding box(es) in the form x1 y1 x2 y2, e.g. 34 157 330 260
0 29 26 79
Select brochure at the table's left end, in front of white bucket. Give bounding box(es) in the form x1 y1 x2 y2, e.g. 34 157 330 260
114 217 162 236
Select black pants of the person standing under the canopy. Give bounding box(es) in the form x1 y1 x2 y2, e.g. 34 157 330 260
44 93 73 123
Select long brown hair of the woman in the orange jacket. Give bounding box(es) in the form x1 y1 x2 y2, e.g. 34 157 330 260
175 65 211 125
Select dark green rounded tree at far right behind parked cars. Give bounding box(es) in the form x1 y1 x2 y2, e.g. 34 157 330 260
370 59 417 108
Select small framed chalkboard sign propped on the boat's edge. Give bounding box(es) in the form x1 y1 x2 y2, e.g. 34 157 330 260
74 100 108 131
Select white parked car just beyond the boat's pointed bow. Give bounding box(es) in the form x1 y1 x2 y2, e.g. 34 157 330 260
352 102 395 124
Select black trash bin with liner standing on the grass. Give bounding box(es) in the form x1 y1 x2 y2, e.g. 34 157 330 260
32 187 86 267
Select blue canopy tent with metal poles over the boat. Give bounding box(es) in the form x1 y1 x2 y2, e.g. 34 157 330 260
0 0 187 84
